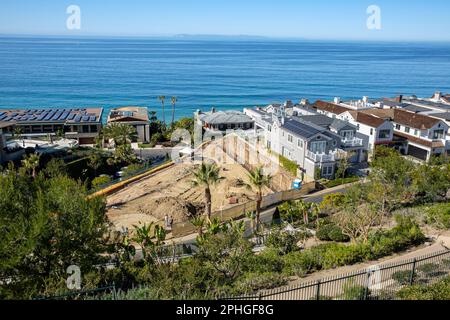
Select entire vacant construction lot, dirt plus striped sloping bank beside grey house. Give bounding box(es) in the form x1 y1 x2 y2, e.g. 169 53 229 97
107 136 295 234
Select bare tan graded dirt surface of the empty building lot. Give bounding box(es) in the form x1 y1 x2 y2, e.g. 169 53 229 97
107 144 272 229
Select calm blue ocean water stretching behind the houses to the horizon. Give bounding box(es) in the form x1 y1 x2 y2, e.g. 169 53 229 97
0 37 450 122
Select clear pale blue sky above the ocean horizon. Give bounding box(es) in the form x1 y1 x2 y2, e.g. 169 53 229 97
0 0 450 41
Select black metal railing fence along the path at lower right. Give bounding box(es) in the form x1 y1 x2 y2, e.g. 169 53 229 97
220 250 450 300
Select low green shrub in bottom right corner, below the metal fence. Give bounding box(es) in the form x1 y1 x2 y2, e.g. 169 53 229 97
397 277 450 300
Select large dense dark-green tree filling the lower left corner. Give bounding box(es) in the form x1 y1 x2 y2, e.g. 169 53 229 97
0 170 110 299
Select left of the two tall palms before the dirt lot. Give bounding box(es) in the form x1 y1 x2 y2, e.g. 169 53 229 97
192 163 223 224
